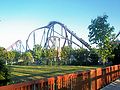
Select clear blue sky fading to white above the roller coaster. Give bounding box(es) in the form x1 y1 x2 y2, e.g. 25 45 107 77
0 0 120 48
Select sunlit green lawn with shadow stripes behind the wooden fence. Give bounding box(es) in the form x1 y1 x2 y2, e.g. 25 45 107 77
10 65 101 83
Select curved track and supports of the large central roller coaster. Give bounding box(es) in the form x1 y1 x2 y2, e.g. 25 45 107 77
26 21 91 50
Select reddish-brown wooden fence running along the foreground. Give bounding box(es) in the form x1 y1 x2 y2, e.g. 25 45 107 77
0 65 120 90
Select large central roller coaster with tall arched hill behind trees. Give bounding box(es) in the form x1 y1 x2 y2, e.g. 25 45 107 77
26 21 91 50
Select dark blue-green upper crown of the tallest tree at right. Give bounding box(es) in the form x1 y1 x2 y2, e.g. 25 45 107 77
88 15 114 46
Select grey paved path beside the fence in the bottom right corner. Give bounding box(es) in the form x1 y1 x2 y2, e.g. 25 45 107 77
101 78 120 90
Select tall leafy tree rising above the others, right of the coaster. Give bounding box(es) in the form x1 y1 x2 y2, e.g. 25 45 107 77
88 15 114 64
